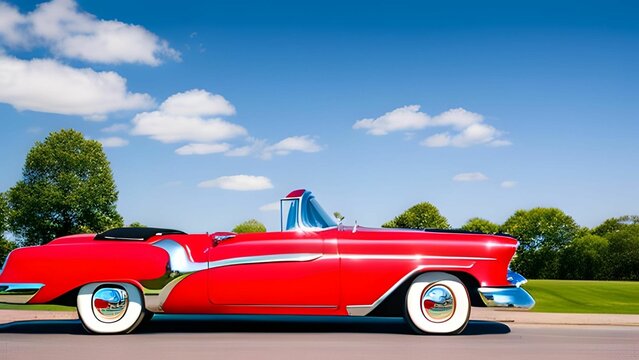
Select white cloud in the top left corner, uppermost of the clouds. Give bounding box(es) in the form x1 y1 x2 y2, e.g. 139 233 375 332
0 0 180 65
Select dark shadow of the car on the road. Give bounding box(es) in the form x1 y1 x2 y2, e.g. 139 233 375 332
0 315 510 335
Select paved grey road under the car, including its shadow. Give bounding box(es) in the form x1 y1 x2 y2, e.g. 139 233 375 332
0 316 639 360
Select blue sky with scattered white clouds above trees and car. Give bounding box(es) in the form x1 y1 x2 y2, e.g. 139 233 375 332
0 0 639 232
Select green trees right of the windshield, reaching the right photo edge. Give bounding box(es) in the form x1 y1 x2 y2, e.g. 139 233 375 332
382 202 639 281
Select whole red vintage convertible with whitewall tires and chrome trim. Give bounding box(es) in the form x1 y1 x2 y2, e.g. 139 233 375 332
0 190 534 334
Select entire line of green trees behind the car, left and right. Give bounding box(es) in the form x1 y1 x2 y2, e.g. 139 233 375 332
0 130 639 280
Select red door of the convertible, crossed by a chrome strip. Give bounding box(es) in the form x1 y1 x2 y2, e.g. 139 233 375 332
208 231 339 307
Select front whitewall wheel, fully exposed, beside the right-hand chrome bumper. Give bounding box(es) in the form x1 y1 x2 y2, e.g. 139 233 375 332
405 272 470 334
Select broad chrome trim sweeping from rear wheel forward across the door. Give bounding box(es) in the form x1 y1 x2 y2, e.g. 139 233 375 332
140 239 322 312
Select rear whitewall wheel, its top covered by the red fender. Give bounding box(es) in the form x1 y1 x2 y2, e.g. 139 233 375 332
77 283 145 334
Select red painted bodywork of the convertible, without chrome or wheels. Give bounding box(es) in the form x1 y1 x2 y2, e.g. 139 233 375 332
0 225 517 315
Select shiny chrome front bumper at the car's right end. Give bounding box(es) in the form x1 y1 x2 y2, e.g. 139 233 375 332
477 270 535 309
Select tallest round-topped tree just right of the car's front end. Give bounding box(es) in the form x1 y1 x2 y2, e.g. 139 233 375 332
501 208 583 279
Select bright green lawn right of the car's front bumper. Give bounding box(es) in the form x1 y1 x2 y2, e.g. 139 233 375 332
524 280 639 314
